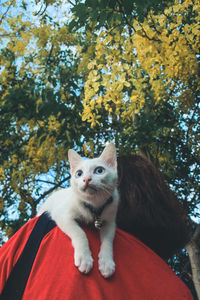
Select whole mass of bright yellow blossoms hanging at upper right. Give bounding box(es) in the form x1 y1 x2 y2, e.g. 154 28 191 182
82 0 200 127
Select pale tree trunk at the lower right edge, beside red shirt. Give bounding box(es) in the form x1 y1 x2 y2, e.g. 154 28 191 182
185 224 200 300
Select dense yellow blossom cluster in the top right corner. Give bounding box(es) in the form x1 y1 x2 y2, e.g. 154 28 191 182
134 0 200 94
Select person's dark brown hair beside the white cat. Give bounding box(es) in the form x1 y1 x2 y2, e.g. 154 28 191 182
117 155 190 259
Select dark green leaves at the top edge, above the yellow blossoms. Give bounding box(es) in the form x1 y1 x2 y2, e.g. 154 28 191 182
69 0 172 30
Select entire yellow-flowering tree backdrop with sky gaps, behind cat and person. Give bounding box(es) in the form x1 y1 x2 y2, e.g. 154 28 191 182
0 0 200 296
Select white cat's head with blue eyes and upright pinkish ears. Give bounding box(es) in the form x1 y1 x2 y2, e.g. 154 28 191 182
68 143 117 205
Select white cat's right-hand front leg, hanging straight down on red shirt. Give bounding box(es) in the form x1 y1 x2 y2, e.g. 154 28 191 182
99 222 116 278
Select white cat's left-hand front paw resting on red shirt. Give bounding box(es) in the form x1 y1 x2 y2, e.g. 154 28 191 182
74 252 93 274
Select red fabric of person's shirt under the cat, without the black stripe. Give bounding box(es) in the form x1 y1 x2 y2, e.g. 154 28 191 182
0 218 193 300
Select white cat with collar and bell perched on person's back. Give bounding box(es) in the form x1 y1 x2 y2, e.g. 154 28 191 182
38 143 119 278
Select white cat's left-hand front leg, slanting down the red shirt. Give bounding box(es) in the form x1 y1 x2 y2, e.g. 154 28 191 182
59 220 93 274
